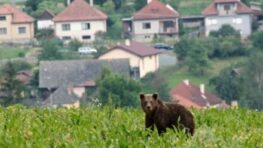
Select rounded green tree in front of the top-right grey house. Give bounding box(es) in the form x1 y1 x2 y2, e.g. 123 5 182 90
210 24 240 38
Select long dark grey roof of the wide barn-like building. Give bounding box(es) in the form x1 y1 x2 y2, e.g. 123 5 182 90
39 59 130 88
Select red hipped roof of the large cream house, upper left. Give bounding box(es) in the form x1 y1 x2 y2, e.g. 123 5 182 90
53 0 107 22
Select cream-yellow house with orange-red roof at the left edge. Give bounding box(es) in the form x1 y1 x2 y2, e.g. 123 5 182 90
0 4 34 42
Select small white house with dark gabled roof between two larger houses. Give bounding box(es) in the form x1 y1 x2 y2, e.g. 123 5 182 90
37 10 54 29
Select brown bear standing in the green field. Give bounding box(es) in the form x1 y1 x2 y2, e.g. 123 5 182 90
140 93 195 135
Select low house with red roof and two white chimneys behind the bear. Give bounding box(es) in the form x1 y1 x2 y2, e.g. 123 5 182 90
170 80 228 109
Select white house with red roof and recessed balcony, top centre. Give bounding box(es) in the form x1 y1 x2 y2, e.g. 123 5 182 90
123 0 179 42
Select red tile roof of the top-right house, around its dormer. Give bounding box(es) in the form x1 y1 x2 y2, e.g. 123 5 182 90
202 0 253 16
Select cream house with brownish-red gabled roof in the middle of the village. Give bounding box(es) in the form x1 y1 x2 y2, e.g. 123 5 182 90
99 40 160 78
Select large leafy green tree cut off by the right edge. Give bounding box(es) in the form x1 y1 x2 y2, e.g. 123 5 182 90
241 53 263 110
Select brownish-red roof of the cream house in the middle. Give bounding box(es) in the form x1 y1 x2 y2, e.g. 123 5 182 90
104 41 161 57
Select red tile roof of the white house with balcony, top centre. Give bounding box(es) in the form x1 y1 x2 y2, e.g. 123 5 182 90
133 0 179 20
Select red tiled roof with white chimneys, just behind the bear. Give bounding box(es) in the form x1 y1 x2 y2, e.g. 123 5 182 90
170 82 223 107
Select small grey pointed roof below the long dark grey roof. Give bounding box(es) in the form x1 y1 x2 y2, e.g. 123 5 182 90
43 86 81 107
